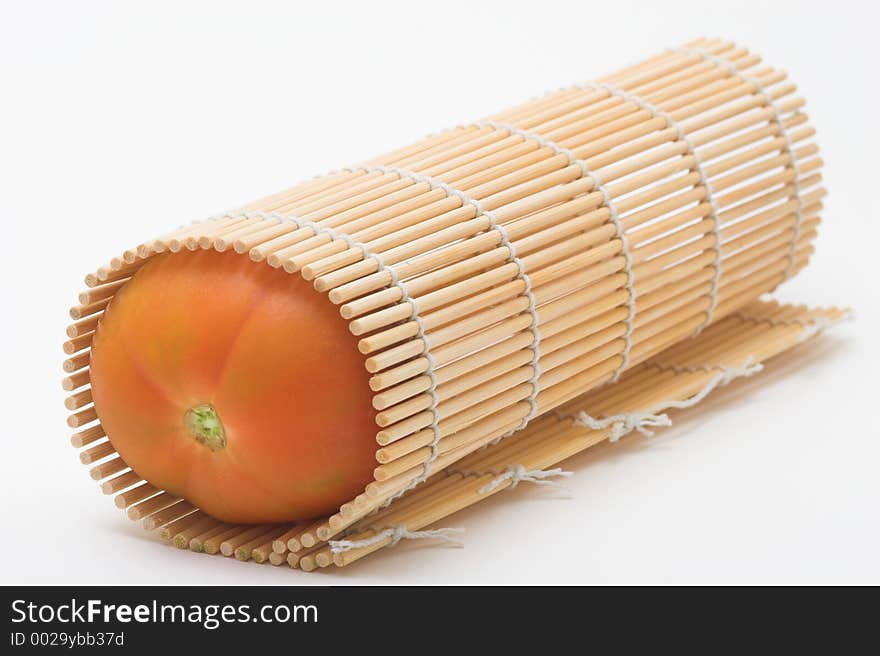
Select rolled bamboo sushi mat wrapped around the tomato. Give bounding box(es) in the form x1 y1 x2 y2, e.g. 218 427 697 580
64 39 836 569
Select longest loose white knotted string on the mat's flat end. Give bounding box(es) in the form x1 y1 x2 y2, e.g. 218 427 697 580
556 357 764 442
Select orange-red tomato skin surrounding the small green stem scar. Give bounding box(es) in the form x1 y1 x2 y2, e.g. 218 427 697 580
91 251 376 523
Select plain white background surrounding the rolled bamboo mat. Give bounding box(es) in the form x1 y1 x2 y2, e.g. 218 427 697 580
0 0 880 584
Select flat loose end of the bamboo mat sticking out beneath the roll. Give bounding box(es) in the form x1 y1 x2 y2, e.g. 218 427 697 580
325 301 849 566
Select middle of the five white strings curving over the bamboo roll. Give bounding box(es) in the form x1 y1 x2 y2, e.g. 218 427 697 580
459 121 636 382
